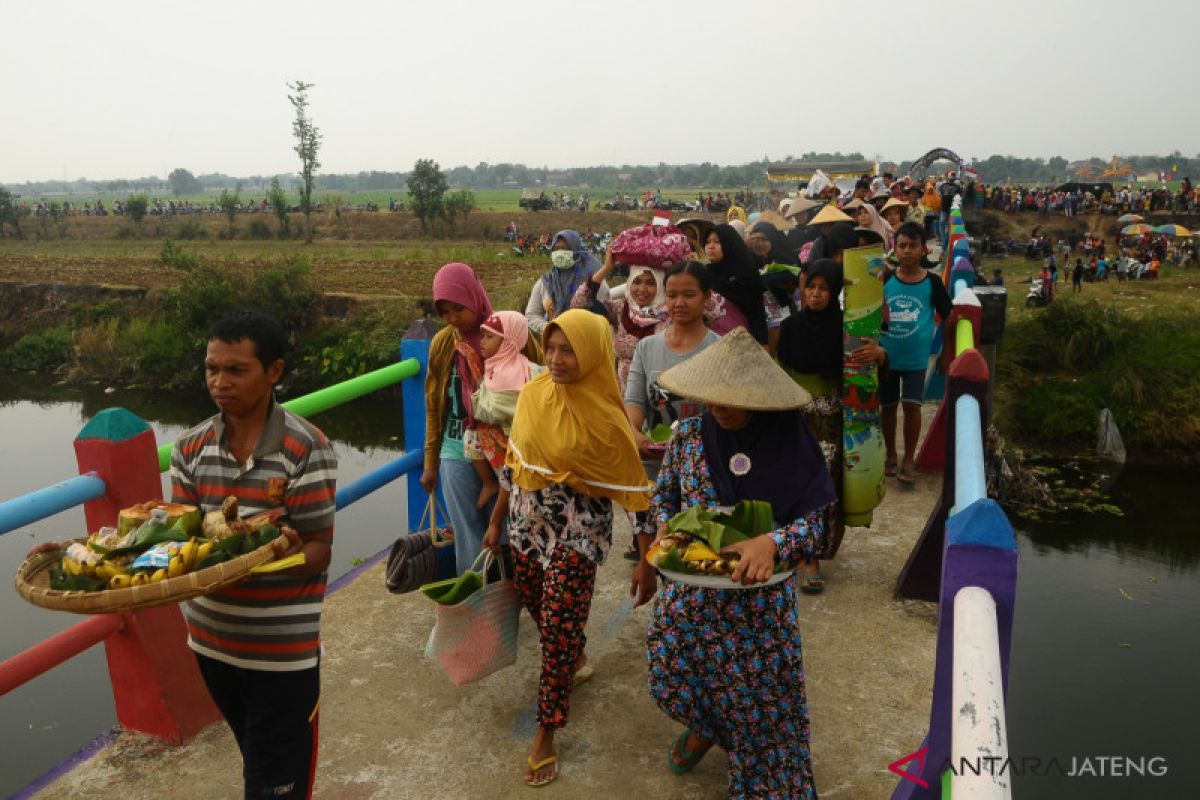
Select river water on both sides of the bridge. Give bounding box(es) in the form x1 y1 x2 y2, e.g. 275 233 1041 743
0 381 1200 800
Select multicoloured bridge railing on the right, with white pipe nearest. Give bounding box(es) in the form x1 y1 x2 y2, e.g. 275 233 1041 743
892 208 1016 800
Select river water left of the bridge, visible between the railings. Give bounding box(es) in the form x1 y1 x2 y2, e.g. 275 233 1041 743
0 380 407 796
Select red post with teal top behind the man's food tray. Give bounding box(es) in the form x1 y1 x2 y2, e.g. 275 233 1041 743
74 408 221 745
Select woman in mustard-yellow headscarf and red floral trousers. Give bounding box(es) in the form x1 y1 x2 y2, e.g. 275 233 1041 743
484 308 656 786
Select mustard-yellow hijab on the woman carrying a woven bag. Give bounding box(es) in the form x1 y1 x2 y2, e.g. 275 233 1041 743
505 308 650 511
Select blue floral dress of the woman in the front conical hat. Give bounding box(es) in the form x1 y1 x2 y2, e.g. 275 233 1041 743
647 417 824 800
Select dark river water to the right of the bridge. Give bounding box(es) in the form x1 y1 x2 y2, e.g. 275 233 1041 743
1008 468 1200 800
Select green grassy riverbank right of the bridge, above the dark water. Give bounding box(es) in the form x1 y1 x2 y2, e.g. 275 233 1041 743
989 259 1200 464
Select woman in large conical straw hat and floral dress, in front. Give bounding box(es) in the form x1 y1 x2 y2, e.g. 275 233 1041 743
640 330 836 799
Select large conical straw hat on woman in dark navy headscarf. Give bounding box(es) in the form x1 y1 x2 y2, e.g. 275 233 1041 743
659 327 812 411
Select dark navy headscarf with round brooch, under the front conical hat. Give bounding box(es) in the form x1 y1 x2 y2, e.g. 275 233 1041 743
700 410 838 527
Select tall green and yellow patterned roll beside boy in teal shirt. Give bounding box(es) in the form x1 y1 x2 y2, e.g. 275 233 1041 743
841 245 887 527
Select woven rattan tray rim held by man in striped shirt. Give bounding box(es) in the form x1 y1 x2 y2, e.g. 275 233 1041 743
13 540 275 614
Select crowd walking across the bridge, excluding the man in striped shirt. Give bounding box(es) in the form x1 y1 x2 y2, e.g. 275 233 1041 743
403 181 949 798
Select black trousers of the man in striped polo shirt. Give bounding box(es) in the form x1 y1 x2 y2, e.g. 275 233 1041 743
196 654 320 800
